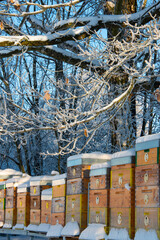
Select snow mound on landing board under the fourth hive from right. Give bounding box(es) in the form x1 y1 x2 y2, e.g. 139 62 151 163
61 222 80 237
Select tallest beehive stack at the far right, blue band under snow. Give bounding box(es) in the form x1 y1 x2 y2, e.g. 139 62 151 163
135 134 160 234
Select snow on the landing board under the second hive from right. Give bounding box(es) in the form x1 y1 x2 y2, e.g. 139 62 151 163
106 228 131 240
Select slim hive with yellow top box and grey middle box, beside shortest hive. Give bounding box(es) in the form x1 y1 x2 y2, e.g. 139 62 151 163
51 173 67 226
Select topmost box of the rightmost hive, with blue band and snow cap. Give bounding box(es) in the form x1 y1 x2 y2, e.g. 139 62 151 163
136 133 160 166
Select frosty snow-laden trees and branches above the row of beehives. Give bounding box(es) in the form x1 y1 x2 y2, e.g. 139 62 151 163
0 0 160 174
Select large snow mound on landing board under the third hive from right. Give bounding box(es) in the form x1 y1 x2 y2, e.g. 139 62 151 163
79 224 106 240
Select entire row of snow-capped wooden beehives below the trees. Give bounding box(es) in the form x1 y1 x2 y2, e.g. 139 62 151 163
0 134 160 239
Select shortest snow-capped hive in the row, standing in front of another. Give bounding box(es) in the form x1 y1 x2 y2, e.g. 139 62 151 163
41 188 52 224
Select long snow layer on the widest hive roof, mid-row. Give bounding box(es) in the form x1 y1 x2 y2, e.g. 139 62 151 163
67 152 112 161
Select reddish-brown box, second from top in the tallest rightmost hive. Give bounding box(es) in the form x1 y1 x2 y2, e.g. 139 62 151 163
135 164 160 187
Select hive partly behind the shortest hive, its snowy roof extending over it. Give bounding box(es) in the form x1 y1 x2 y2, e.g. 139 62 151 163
30 176 53 225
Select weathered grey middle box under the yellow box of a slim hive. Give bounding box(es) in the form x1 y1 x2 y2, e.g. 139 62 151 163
52 197 65 213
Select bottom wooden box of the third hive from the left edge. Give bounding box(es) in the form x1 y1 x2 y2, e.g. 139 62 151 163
17 208 30 226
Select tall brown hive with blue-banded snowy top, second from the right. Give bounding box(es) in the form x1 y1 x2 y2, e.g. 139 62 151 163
110 149 135 238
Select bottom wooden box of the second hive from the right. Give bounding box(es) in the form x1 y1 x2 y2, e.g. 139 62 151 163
110 208 135 238
